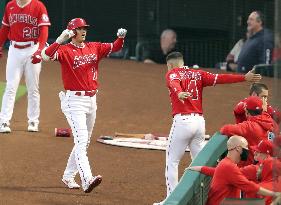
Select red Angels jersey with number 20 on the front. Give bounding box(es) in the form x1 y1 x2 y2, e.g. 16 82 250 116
2 0 51 42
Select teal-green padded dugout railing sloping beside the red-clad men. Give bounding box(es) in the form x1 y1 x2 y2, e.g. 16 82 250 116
164 132 227 205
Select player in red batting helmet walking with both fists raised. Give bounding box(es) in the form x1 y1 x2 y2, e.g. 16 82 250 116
42 18 127 193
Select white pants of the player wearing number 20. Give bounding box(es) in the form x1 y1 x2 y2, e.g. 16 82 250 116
0 44 41 124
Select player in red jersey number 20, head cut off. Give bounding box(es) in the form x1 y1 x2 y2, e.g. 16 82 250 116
0 0 50 133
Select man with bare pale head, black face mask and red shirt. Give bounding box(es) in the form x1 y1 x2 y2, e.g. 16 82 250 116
188 135 281 205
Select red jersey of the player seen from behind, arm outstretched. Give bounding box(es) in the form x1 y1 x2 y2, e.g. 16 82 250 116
166 67 245 116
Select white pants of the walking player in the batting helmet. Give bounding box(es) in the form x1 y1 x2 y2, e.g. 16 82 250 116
59 91 97 188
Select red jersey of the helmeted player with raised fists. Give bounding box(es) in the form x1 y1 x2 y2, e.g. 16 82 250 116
52 38 124 91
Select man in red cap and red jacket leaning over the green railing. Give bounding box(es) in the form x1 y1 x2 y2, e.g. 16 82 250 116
220 96 274 166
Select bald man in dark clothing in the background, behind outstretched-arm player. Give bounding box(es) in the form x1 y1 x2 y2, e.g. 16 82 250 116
143 29 177 64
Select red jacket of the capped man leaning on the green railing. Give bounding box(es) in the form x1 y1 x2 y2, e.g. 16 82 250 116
220 112 274 166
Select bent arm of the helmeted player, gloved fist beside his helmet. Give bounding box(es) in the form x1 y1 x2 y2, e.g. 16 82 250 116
41 29 75 61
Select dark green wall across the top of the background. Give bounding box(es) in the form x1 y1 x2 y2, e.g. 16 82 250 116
38 0 274 40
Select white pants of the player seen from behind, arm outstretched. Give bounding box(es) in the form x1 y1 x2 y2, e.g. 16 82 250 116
165 114 205 196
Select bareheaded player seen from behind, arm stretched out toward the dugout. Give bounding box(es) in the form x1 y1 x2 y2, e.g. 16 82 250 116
154 52 261 205
